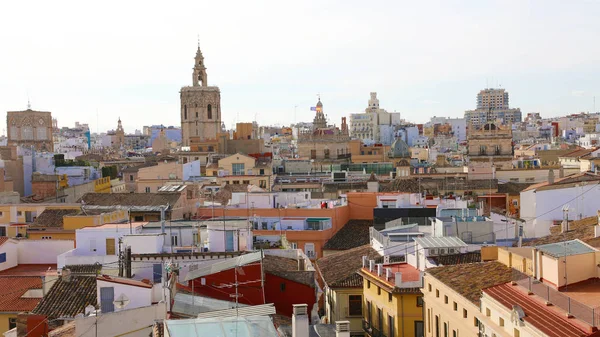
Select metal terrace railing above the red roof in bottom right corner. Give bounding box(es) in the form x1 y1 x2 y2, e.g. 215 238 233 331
513 270 600 327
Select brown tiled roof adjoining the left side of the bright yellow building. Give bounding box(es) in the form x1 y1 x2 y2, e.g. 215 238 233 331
317 244 381 288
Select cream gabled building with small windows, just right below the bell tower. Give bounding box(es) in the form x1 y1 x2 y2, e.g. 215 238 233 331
206 153 273 191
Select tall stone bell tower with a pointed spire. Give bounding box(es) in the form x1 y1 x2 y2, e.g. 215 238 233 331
179 44 221 147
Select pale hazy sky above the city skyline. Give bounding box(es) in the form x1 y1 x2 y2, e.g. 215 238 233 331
0 0 600 133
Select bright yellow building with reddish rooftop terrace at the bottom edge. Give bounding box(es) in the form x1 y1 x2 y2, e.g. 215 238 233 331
359 258 424 337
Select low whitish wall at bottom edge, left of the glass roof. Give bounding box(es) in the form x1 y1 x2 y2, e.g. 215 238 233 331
75 303 166 337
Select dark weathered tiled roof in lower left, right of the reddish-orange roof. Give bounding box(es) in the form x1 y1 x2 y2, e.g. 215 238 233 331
33 275 97 319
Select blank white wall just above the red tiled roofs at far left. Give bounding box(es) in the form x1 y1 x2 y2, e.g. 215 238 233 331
17 240 75 264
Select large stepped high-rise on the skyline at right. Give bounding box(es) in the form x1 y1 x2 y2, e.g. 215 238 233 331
465 88 522 128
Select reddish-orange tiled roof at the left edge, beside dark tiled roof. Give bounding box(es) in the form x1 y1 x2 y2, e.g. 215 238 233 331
0 276 42 312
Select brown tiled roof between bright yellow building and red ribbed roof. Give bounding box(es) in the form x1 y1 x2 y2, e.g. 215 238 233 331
426 261 513 305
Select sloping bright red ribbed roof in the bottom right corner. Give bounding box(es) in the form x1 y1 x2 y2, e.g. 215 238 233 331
483 283 592 337
